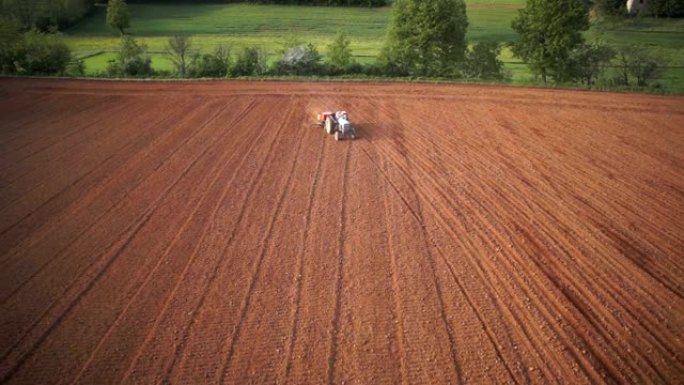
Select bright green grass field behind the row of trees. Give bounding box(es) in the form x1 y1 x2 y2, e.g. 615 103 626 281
64 0 684 92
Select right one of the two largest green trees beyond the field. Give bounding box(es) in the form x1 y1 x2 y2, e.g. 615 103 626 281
512 0 589 83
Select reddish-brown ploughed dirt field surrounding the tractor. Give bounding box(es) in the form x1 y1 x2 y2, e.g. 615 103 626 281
0 79 684 384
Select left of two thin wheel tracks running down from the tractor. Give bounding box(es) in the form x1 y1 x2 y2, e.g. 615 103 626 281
282 136 328 384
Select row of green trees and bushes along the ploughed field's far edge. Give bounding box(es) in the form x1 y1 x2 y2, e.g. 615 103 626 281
0 0 681 91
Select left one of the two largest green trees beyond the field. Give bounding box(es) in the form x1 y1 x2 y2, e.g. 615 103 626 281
380 0 468 76
